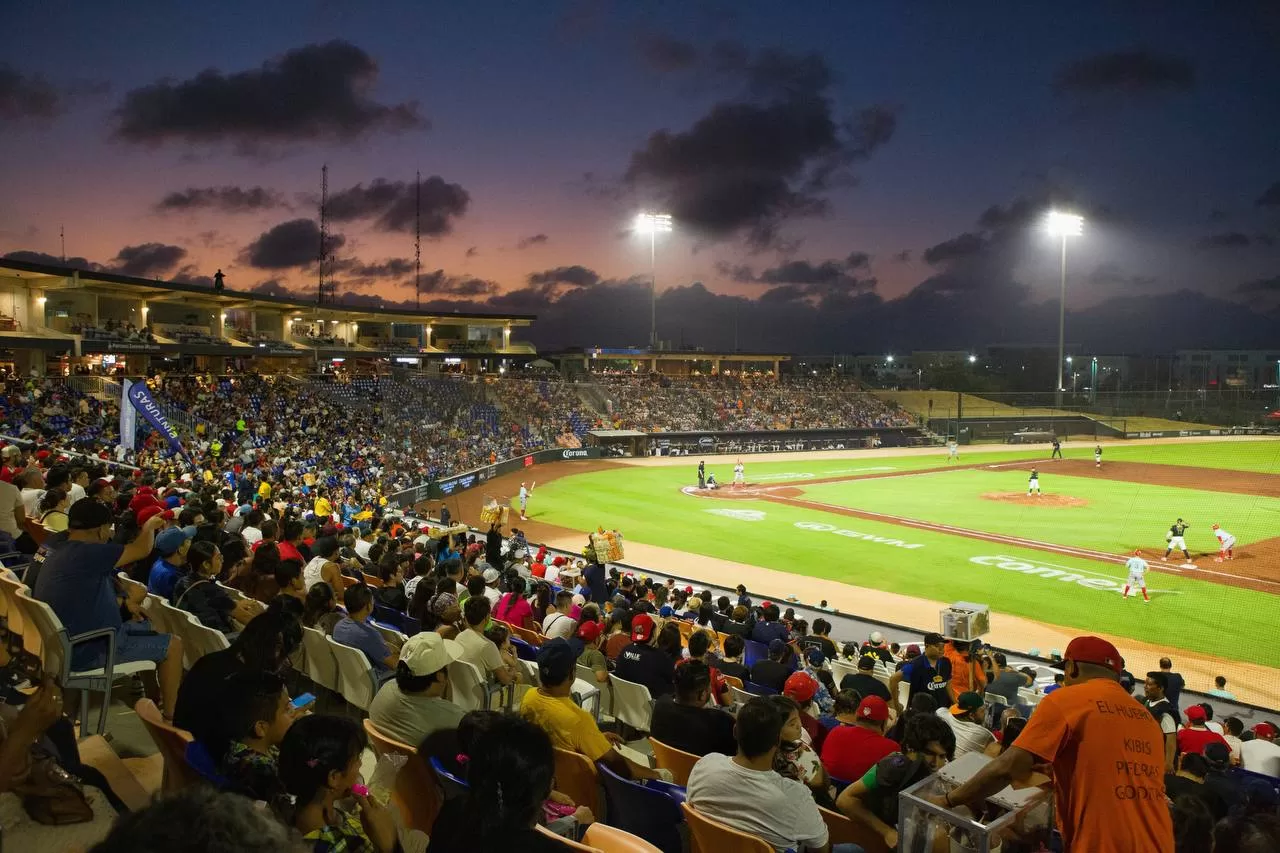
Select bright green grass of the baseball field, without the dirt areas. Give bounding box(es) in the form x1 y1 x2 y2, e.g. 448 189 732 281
530 442 1280 666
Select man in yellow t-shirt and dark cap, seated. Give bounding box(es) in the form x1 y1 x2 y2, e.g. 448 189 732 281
520 638 673 781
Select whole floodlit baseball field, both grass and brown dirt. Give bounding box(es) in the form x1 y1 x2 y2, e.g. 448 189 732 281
460 438 1280 707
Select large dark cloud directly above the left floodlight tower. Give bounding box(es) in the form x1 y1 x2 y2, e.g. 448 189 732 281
623 49 897 247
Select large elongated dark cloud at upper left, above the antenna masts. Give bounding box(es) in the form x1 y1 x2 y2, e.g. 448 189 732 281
115 41 428 154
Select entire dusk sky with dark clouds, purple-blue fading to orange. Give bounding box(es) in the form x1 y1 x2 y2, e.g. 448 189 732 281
0 0 1280 351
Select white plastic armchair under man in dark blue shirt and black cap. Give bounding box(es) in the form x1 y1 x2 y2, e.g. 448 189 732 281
13 593 156 735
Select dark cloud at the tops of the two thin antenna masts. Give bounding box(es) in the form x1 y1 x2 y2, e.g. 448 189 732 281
326 174 471 237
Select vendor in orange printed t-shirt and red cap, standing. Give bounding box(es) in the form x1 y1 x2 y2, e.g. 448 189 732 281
933 637 1174 853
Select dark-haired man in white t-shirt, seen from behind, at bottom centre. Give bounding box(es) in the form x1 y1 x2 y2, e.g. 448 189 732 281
687 697 845 853
